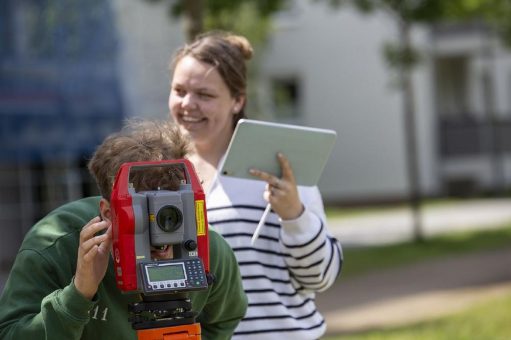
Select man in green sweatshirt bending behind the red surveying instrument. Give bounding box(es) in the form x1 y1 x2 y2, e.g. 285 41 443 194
0 122 247 340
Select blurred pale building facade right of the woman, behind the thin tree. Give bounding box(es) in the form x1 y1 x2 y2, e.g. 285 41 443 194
261 0 511 202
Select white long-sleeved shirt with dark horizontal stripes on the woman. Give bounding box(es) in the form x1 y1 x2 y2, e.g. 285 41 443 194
207 177 342 340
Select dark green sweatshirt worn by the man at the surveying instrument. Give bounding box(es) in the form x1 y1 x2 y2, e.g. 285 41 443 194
0 197 247 340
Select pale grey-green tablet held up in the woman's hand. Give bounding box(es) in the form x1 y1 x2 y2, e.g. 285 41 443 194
220 119 337 186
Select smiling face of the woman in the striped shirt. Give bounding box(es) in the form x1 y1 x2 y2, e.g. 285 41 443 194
169 56 243 149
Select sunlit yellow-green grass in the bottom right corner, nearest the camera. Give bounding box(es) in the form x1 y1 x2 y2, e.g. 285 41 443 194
324 294 511 340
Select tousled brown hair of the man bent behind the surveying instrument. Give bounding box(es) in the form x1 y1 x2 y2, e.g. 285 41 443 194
88 120 189 200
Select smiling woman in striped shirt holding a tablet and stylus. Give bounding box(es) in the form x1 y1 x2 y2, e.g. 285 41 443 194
169 32 342 340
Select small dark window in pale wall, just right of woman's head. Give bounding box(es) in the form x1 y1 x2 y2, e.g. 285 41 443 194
272 78 301 120
